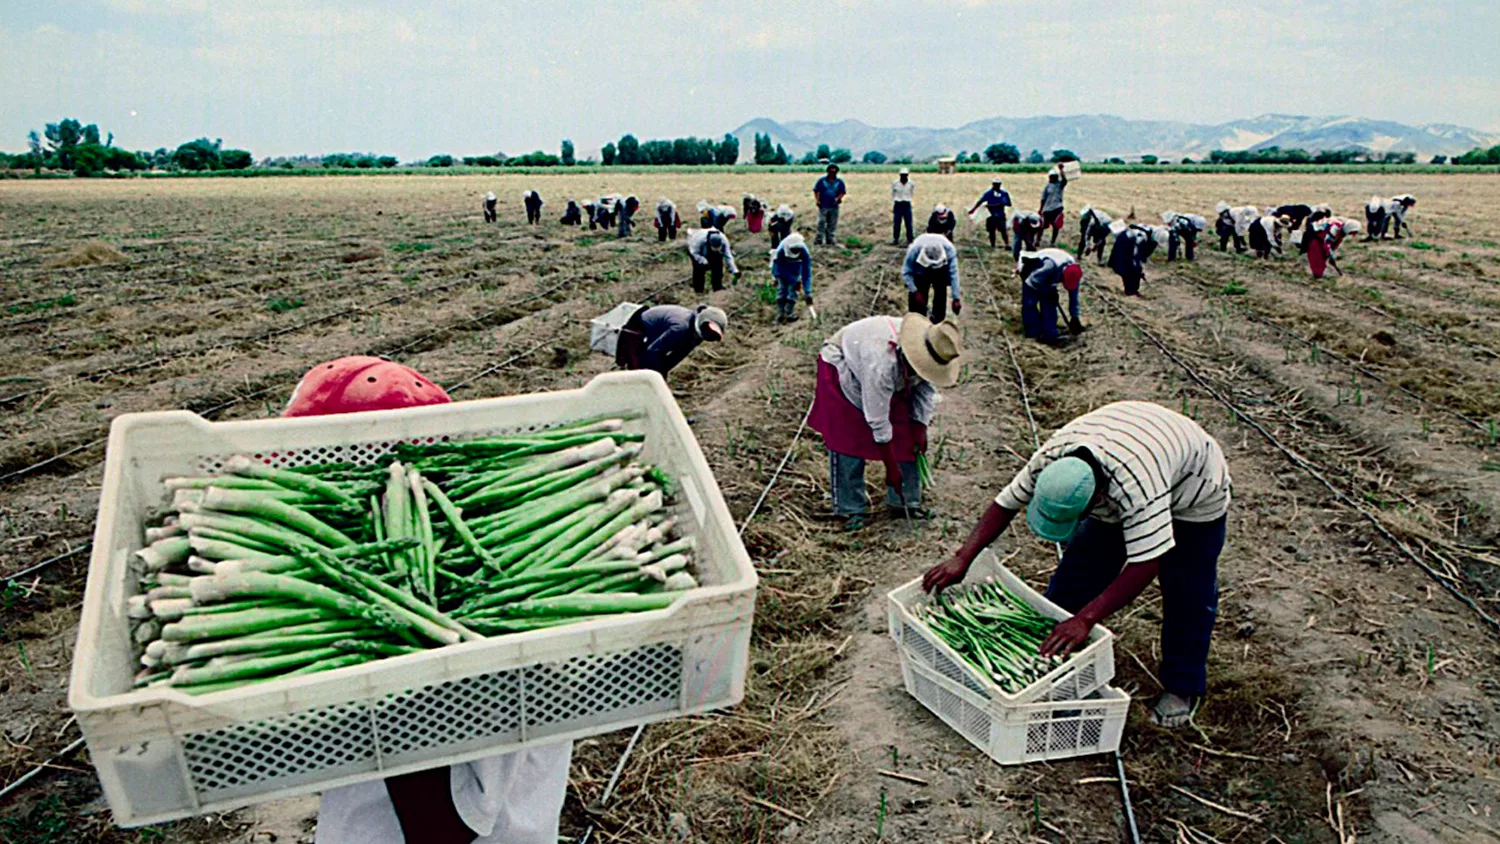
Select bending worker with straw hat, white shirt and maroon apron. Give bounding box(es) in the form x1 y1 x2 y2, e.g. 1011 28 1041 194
807 313 965 531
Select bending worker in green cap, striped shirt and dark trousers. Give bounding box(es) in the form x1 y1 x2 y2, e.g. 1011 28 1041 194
923 402 1232 727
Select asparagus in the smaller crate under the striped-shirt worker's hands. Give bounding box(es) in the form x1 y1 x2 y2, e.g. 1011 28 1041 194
917 580 1062 694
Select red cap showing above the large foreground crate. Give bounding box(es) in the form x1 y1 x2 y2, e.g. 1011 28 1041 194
282 355 453 417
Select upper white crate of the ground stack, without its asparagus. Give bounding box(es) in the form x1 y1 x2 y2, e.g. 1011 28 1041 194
887 550 1115 706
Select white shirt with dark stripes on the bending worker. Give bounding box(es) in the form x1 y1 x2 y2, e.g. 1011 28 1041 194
995 402 1230 562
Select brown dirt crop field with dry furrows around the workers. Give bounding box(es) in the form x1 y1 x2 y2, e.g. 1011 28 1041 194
0 174 1500 844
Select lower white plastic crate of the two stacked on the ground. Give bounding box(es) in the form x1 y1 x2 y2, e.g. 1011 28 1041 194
902 652 1130 765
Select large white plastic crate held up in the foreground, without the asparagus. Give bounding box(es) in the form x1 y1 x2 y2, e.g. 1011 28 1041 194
68 372 756 826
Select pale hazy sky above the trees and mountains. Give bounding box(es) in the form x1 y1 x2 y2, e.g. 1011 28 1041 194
0 0 1500 159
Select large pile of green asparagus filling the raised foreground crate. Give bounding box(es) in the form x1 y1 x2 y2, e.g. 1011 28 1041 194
126 418 698 693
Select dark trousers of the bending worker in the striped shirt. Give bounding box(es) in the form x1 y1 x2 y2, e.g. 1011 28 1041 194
1047 516 1227 697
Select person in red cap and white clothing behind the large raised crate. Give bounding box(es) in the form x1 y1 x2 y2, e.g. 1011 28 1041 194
298 357 573 844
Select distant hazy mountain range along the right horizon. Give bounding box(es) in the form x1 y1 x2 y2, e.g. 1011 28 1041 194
732 114 1500 160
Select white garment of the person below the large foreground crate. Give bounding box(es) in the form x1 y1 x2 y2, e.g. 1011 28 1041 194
314 742 573 844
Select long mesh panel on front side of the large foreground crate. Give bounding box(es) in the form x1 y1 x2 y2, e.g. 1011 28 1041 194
183 643 683 802
